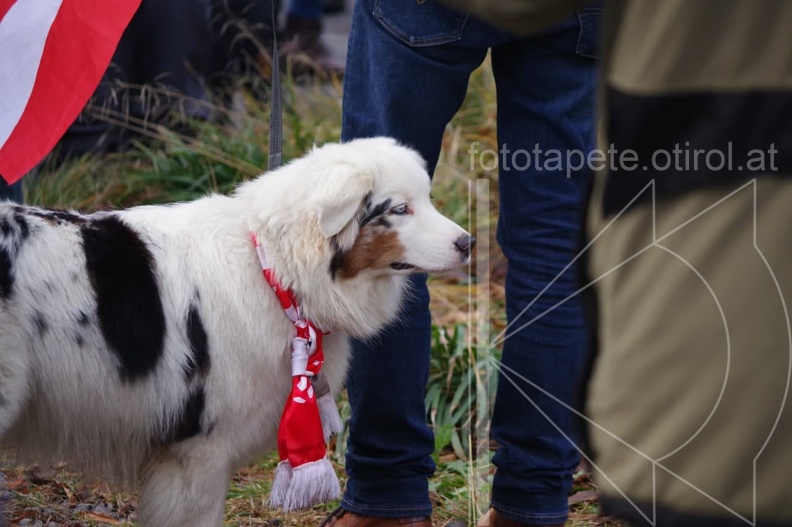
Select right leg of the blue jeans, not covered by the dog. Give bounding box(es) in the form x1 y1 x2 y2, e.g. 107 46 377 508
491 11 596 524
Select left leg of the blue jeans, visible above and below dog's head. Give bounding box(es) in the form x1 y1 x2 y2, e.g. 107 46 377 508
342 0 486 517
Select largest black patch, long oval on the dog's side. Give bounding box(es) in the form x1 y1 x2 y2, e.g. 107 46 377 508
81 216 165 381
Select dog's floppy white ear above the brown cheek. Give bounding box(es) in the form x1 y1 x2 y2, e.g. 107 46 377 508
319 170 374 238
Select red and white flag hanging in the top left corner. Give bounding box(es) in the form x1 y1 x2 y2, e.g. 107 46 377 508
0 0 141 183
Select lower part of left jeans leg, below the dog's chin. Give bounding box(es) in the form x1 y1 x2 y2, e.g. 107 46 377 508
342 276 435 517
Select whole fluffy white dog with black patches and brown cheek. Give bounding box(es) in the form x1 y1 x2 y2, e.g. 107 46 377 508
0 138 474 527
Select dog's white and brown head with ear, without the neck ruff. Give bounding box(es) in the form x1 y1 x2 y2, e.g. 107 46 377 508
316 138 475 280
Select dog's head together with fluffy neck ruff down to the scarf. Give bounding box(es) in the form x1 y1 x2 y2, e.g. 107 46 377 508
237 138 475 337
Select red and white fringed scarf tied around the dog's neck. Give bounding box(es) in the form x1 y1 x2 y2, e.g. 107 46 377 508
251 233 342 511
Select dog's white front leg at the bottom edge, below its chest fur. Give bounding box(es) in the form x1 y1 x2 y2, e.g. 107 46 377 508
138 446 232 527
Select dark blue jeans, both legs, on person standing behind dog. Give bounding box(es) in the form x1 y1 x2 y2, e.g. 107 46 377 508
342 0 599 524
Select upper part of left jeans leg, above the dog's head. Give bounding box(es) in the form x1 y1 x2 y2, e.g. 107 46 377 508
341 0 487 174
